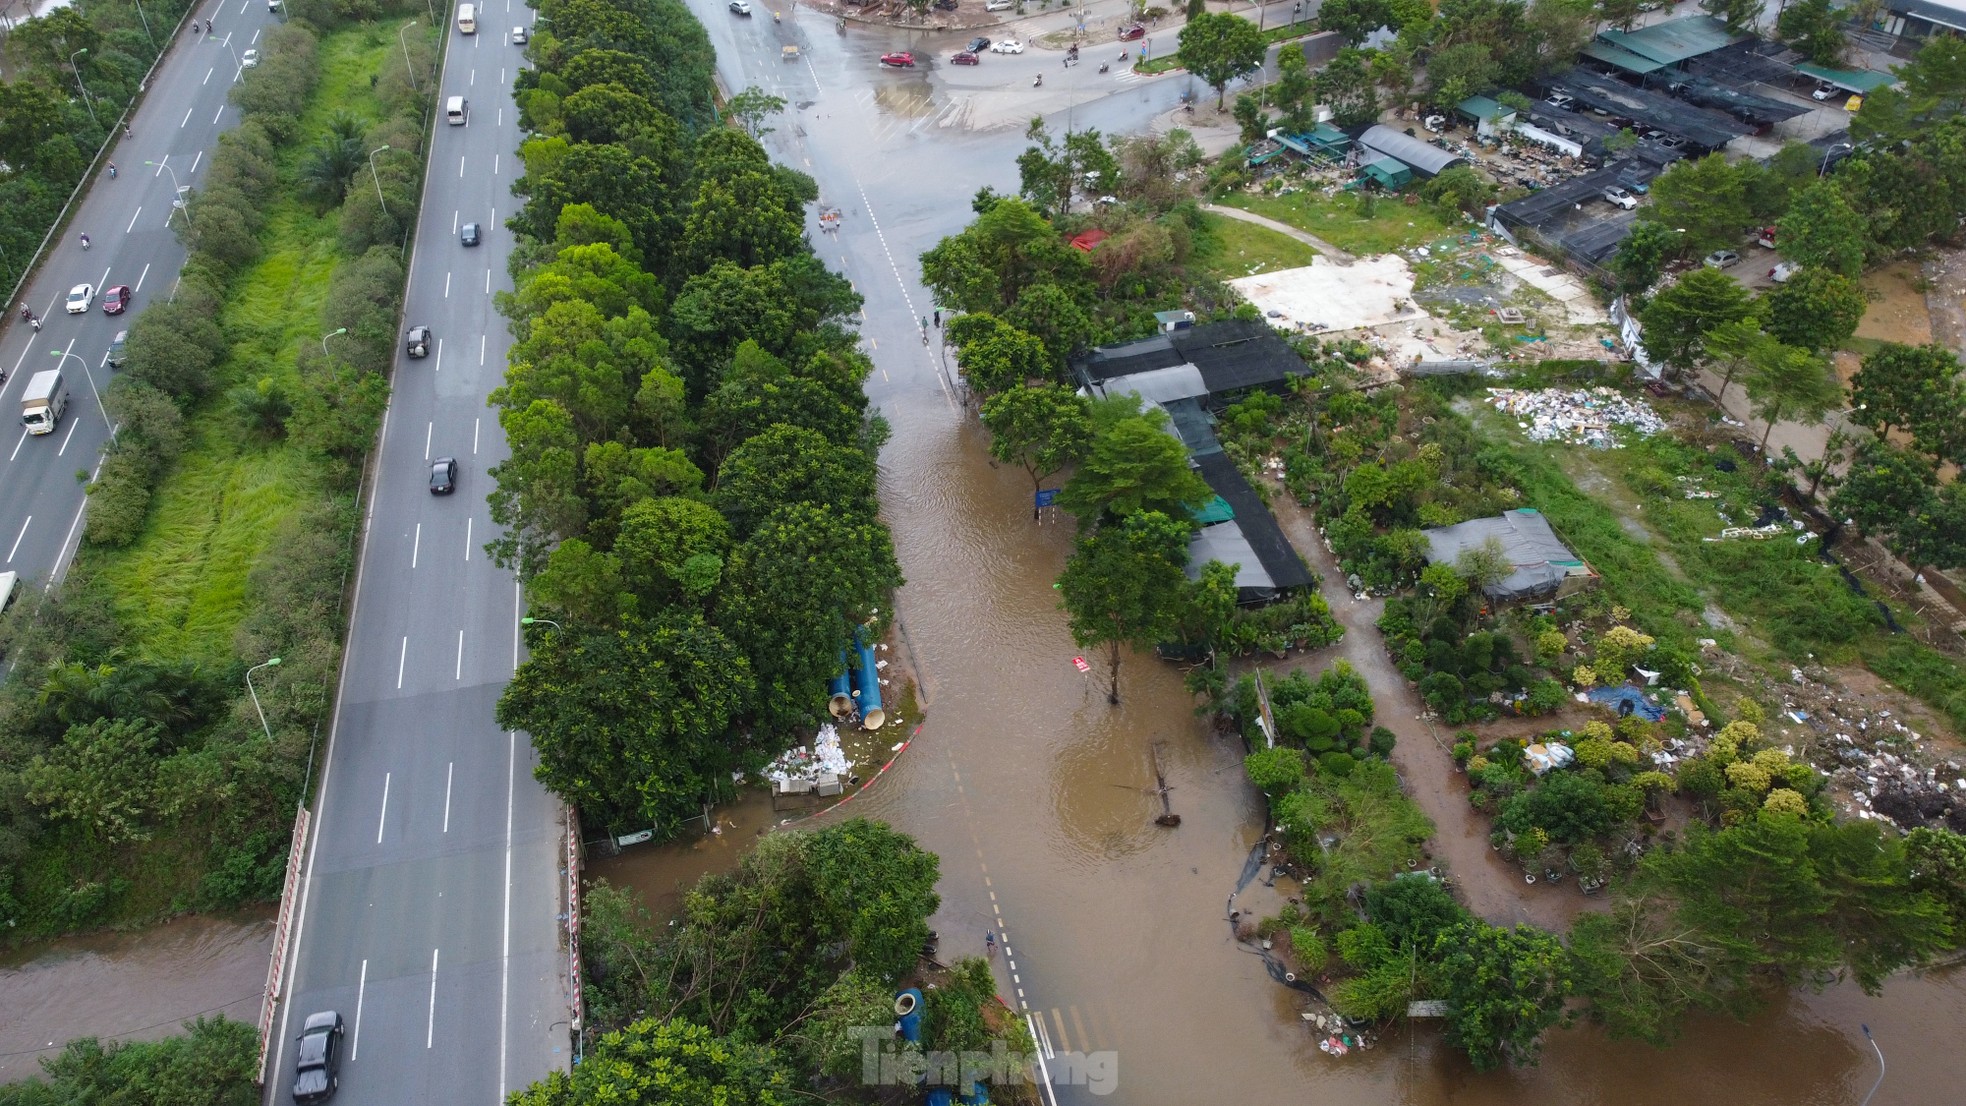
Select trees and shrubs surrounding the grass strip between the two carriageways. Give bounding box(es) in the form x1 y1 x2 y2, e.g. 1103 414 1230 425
0 4 431 941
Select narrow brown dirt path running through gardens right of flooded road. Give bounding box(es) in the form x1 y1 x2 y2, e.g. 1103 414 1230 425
1270 481 1608 931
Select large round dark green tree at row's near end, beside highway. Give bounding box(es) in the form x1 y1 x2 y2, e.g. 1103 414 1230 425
497 613 759 837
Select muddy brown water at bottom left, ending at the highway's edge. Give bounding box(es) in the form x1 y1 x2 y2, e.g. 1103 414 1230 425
0 910 273 1082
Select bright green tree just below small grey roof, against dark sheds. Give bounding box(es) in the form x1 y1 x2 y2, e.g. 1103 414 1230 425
1058 409 1211 526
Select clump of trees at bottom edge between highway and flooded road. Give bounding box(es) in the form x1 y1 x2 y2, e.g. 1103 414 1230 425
538 819 1030 1106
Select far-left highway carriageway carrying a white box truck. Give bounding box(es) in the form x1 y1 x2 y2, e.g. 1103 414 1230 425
0 0 277 587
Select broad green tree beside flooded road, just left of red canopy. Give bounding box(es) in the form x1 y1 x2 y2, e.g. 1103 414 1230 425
922 198 1087 314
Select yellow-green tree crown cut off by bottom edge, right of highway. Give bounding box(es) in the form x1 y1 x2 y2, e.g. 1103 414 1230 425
511 1018 798 1106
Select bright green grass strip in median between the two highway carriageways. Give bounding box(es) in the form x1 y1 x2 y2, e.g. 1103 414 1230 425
85 28 422 667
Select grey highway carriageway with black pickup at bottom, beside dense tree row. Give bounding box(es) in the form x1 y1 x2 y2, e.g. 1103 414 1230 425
267 0 570 1106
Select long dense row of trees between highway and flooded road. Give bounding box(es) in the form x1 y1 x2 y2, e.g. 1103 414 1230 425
490 0 900 835
